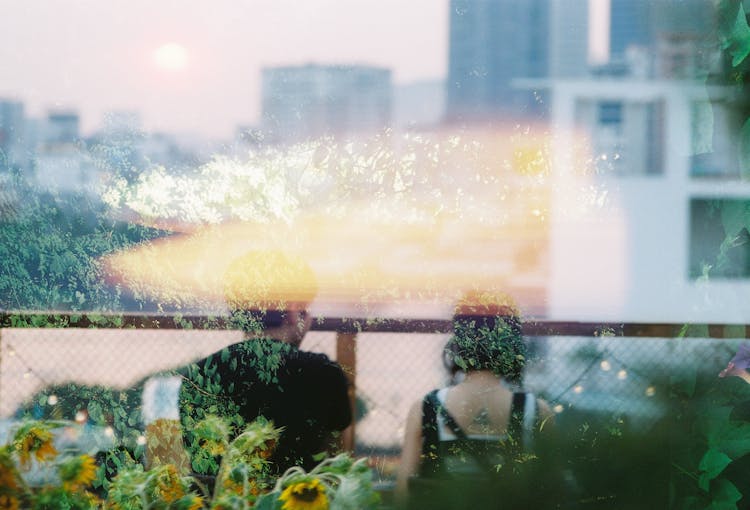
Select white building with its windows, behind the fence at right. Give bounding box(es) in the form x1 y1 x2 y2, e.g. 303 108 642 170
548 79 750 323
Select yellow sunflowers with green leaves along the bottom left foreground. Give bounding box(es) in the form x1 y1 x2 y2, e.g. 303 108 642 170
0 416 379 510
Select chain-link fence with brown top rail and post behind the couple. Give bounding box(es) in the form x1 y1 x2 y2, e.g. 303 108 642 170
0 312 750 454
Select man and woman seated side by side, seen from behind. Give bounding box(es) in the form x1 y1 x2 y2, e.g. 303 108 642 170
179 266 552 502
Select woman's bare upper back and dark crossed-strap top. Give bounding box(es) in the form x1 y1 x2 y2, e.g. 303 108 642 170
409 372 548 509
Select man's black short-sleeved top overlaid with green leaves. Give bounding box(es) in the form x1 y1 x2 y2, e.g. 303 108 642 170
179 339 352 472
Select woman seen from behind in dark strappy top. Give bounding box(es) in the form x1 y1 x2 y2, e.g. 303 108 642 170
396 293 552 508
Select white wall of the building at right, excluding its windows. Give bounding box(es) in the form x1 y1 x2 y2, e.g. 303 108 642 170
548 80 750 323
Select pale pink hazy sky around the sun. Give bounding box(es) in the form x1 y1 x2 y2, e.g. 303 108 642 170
0 0 449 138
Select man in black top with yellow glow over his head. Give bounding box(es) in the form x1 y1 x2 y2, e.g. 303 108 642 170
177 252 352 474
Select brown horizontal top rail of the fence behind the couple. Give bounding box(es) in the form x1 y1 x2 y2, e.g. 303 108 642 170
0 312 750 338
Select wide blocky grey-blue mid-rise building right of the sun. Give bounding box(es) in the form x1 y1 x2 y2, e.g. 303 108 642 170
262 64 392 142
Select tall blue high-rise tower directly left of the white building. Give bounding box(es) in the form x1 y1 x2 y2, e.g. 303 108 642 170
446 0 550 122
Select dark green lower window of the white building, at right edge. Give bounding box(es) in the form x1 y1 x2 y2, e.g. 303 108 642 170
689 198 750 278
